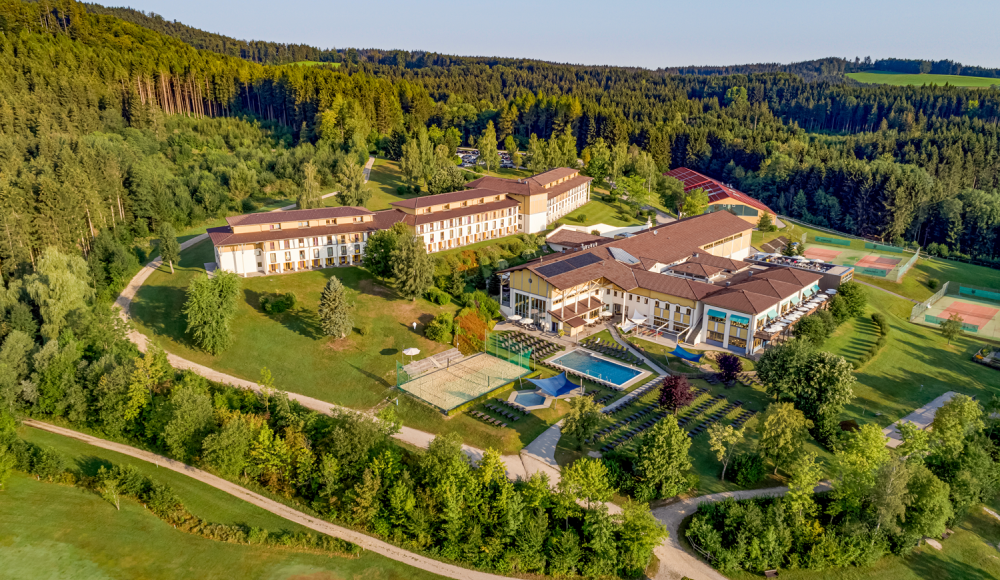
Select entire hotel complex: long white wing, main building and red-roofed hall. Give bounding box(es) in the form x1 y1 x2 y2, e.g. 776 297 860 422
209 163 836 354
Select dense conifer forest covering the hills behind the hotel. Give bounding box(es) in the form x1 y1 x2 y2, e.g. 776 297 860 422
0 0 1000 280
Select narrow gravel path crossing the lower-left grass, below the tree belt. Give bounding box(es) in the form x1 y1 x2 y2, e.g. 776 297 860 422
24 419 506 580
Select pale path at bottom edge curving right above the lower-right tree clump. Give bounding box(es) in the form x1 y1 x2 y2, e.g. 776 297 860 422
652 483 830 580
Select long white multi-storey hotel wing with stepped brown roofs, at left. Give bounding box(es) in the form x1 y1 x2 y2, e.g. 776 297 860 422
208 168 592 275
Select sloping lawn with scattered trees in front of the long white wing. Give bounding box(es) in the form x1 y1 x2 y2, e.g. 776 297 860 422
131 242 548 453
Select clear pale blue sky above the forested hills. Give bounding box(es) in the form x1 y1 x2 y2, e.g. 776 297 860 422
111 0 1000 68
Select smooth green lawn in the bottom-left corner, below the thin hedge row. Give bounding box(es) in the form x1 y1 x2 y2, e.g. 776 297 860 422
0 473 439 580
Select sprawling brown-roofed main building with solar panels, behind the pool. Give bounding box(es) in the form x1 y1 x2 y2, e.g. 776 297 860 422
501 212 822 355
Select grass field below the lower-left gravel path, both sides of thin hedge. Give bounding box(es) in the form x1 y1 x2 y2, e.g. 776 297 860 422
0 427 439 580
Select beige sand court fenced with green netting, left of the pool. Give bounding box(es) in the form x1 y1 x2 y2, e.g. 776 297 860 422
399 353 531 411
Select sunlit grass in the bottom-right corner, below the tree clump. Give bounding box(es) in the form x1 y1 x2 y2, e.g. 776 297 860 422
724 499 1000 580
